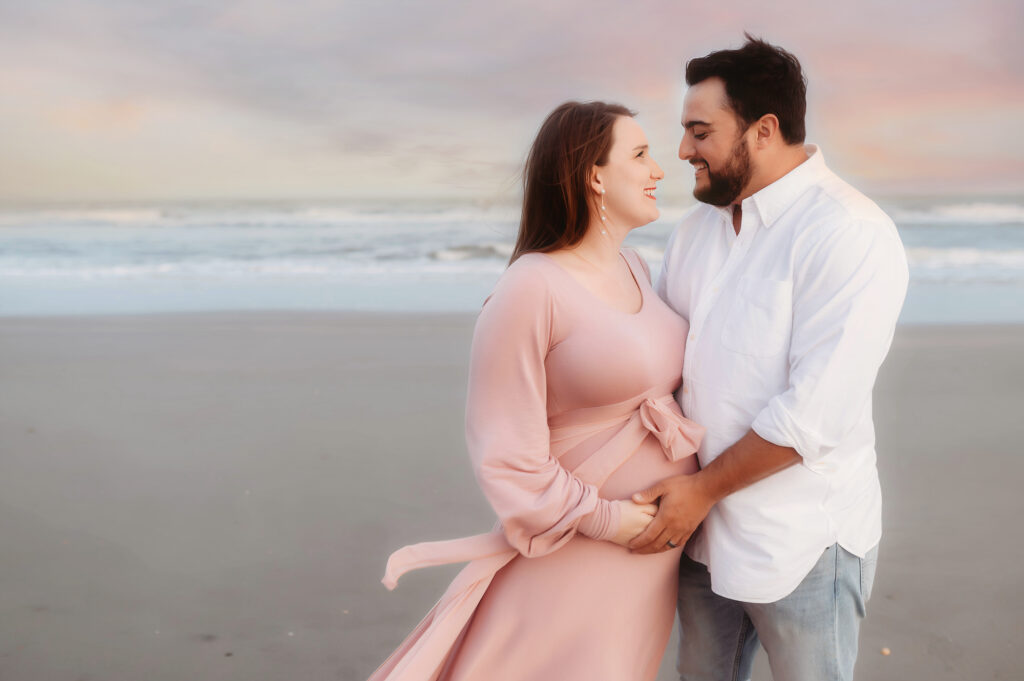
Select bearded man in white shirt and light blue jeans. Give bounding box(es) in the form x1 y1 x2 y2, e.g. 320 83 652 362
631 36 907 681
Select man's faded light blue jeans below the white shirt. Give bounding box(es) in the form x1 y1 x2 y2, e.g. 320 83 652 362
676 544 879 681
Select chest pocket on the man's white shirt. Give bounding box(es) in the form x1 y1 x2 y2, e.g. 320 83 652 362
722 276 793 357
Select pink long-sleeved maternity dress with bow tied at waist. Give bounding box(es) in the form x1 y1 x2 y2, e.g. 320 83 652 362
371 251 703 681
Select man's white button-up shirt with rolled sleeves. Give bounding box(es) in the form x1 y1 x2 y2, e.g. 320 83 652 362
657 145 907 602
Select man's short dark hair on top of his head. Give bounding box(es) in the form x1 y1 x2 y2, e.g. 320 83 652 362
686 33 807 144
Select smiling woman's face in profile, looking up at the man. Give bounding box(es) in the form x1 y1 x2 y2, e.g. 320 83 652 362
592 116 665 229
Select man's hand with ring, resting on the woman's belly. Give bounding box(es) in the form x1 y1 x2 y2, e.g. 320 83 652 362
629 472 718 553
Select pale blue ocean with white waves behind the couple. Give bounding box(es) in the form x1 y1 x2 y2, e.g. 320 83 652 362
0 199 1024 324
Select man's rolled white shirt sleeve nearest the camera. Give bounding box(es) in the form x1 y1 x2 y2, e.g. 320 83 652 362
752 220 908 463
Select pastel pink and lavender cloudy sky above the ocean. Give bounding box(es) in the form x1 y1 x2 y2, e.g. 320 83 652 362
0 0 1024 201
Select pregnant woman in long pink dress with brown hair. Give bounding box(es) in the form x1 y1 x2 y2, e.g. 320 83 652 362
371 102 703 681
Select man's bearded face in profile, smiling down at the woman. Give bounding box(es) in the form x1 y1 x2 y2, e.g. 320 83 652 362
679 78 754 206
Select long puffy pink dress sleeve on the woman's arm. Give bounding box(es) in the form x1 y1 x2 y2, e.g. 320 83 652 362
466 261 618 556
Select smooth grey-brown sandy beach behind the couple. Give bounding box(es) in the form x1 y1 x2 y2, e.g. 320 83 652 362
0 313 1024 681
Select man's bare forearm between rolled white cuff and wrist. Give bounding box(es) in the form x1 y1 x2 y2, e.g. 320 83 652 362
697 430 801 502
